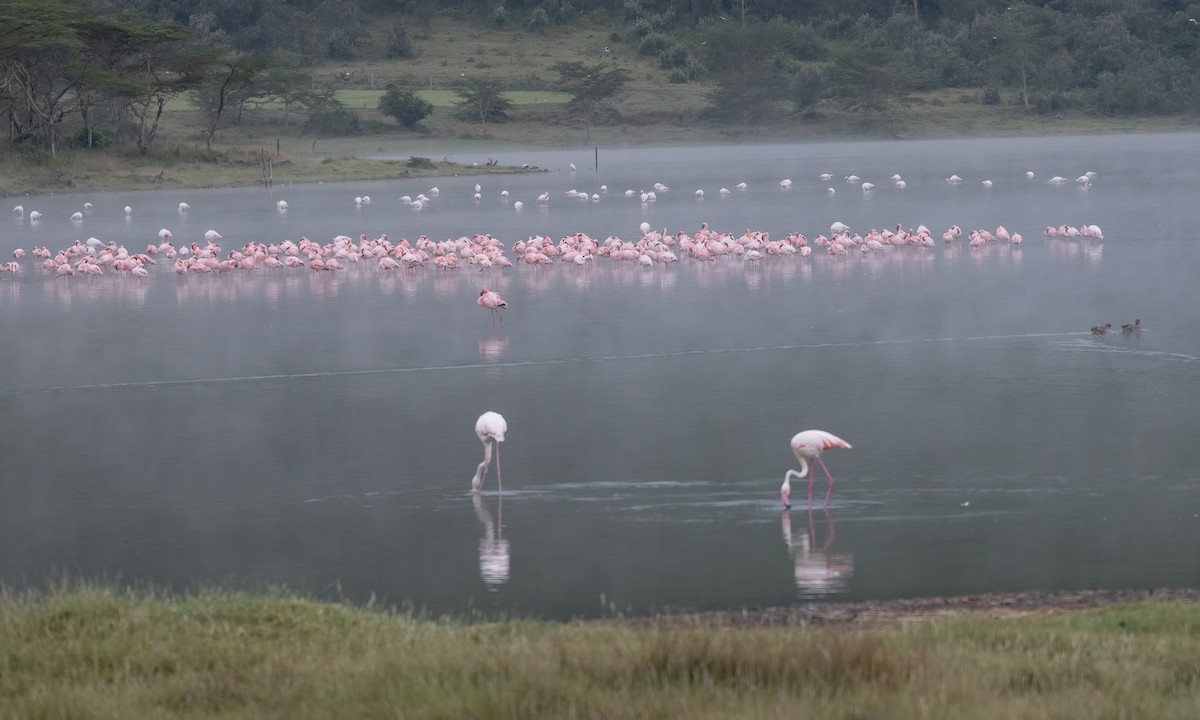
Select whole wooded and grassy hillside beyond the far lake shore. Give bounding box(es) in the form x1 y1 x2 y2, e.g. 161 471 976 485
0 0 1200 193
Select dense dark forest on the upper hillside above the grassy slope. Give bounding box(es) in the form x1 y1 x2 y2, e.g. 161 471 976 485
106 0 1200 120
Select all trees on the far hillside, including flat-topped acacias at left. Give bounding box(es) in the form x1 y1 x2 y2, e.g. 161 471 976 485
0 0 1200 155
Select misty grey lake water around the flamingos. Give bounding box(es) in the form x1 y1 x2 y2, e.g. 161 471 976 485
0 134 1200 618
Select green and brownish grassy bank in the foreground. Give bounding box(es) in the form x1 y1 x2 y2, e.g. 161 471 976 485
0 587 1200 719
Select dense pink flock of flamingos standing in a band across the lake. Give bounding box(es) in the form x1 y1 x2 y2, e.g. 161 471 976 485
0 200 1104 284
